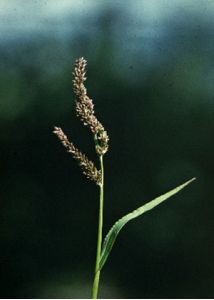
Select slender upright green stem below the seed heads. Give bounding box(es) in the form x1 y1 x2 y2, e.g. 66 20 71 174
91 155 104 299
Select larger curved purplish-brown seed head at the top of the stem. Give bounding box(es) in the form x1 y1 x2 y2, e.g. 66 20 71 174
73 57 109 155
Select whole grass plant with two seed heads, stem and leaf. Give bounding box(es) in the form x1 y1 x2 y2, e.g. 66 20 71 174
53 57 195 299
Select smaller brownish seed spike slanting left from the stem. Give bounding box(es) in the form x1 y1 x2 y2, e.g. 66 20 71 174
53 127 101 185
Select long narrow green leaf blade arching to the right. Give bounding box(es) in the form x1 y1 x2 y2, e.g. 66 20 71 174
99 178 196 270
